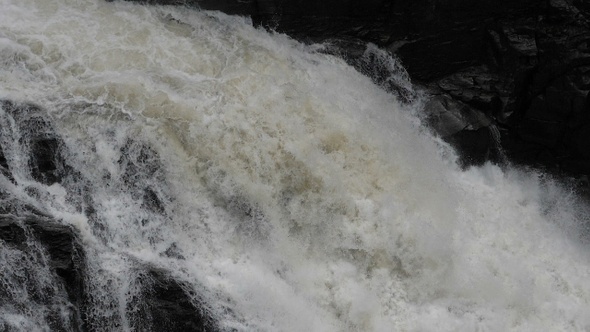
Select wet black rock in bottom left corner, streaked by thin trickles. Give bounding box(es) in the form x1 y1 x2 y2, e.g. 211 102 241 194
0 212 85 331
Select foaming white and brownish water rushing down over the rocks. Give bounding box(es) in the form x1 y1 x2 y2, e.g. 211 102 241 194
0 0 590 331
